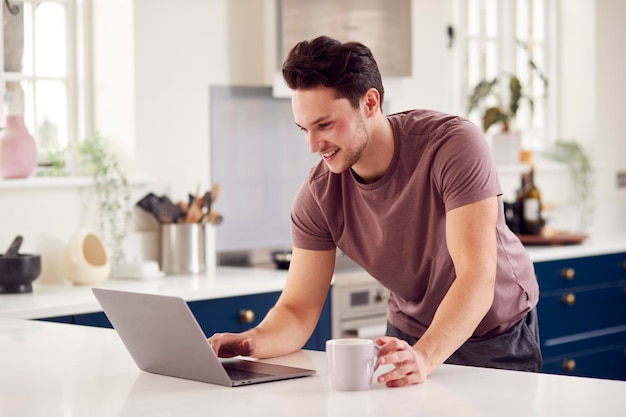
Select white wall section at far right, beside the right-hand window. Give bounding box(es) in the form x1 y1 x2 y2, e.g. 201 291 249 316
538 0 626 233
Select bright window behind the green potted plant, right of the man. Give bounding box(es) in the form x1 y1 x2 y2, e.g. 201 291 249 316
454 0 554 150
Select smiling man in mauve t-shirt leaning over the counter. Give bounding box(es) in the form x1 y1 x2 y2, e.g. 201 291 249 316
209 37 541 387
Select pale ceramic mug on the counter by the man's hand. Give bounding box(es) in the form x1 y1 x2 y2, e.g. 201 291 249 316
326 338 379 391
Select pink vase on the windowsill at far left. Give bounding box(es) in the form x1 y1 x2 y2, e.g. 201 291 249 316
0 114 37 178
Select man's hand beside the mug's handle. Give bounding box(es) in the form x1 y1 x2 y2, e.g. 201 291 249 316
376 336 430 387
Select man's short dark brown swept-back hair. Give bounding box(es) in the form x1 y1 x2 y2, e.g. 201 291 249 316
283 36 385 110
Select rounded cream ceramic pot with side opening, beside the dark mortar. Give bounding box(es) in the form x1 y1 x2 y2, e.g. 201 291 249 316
61 230 111 285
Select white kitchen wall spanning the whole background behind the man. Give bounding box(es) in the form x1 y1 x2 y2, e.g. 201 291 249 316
0 0 626 281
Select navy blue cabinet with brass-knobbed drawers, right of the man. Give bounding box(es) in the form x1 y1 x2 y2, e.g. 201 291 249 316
535 253 626 380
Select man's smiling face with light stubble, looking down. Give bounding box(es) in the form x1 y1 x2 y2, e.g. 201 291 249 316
291 87 369 174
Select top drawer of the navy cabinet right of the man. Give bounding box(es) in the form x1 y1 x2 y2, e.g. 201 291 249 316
535 253 626 291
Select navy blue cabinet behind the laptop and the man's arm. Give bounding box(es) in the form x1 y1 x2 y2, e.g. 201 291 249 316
40 291 330 351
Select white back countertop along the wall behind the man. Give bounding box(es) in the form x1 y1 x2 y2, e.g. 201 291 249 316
0 232 626 319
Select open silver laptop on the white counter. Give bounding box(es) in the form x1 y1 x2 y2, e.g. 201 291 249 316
92 288 315 387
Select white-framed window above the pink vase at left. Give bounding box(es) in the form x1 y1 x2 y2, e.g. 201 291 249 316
2 0 78 161
